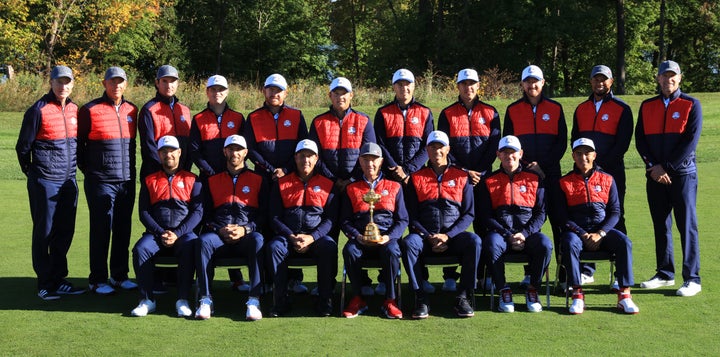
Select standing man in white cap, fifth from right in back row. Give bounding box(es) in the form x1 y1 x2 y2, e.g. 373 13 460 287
373 68 435 295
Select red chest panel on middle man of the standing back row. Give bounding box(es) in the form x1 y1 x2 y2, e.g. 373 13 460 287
313 112 368 150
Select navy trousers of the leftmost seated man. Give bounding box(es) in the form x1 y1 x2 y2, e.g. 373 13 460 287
133 232 197 301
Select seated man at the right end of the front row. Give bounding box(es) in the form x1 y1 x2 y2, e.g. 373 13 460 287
557 138 640 315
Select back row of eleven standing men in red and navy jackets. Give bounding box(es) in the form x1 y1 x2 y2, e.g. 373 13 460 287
16 61 702 319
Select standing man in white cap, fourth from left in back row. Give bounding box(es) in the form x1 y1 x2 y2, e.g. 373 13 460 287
189 74 250 292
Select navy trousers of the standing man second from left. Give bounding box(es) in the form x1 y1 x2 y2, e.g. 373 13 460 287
84 178 135 284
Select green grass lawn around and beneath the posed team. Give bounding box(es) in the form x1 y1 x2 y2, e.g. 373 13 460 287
0 93 720 356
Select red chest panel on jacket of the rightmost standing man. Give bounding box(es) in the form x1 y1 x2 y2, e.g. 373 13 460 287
641 98 692 135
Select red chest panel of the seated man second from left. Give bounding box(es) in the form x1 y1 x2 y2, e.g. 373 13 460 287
208 171 262 208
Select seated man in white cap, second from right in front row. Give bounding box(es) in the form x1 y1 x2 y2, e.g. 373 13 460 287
476 135 553 312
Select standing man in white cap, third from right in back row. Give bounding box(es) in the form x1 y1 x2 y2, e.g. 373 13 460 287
503 65 567 285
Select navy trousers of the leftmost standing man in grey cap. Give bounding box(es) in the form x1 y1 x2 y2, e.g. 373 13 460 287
27 172 78 291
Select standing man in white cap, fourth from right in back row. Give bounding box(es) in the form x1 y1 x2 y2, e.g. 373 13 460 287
438 68 500 291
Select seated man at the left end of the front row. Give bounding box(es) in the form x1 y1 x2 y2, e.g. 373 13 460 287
130 135 202 317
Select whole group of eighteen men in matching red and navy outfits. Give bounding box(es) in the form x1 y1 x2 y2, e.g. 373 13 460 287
16 60 702 321
